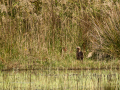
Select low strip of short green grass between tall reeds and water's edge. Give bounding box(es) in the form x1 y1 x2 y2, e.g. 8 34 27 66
1 56 120 71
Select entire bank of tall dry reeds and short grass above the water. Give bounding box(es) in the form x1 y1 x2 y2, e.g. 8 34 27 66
0 0 120 69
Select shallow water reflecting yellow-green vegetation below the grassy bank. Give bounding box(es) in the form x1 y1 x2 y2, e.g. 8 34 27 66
0 70 120 90
